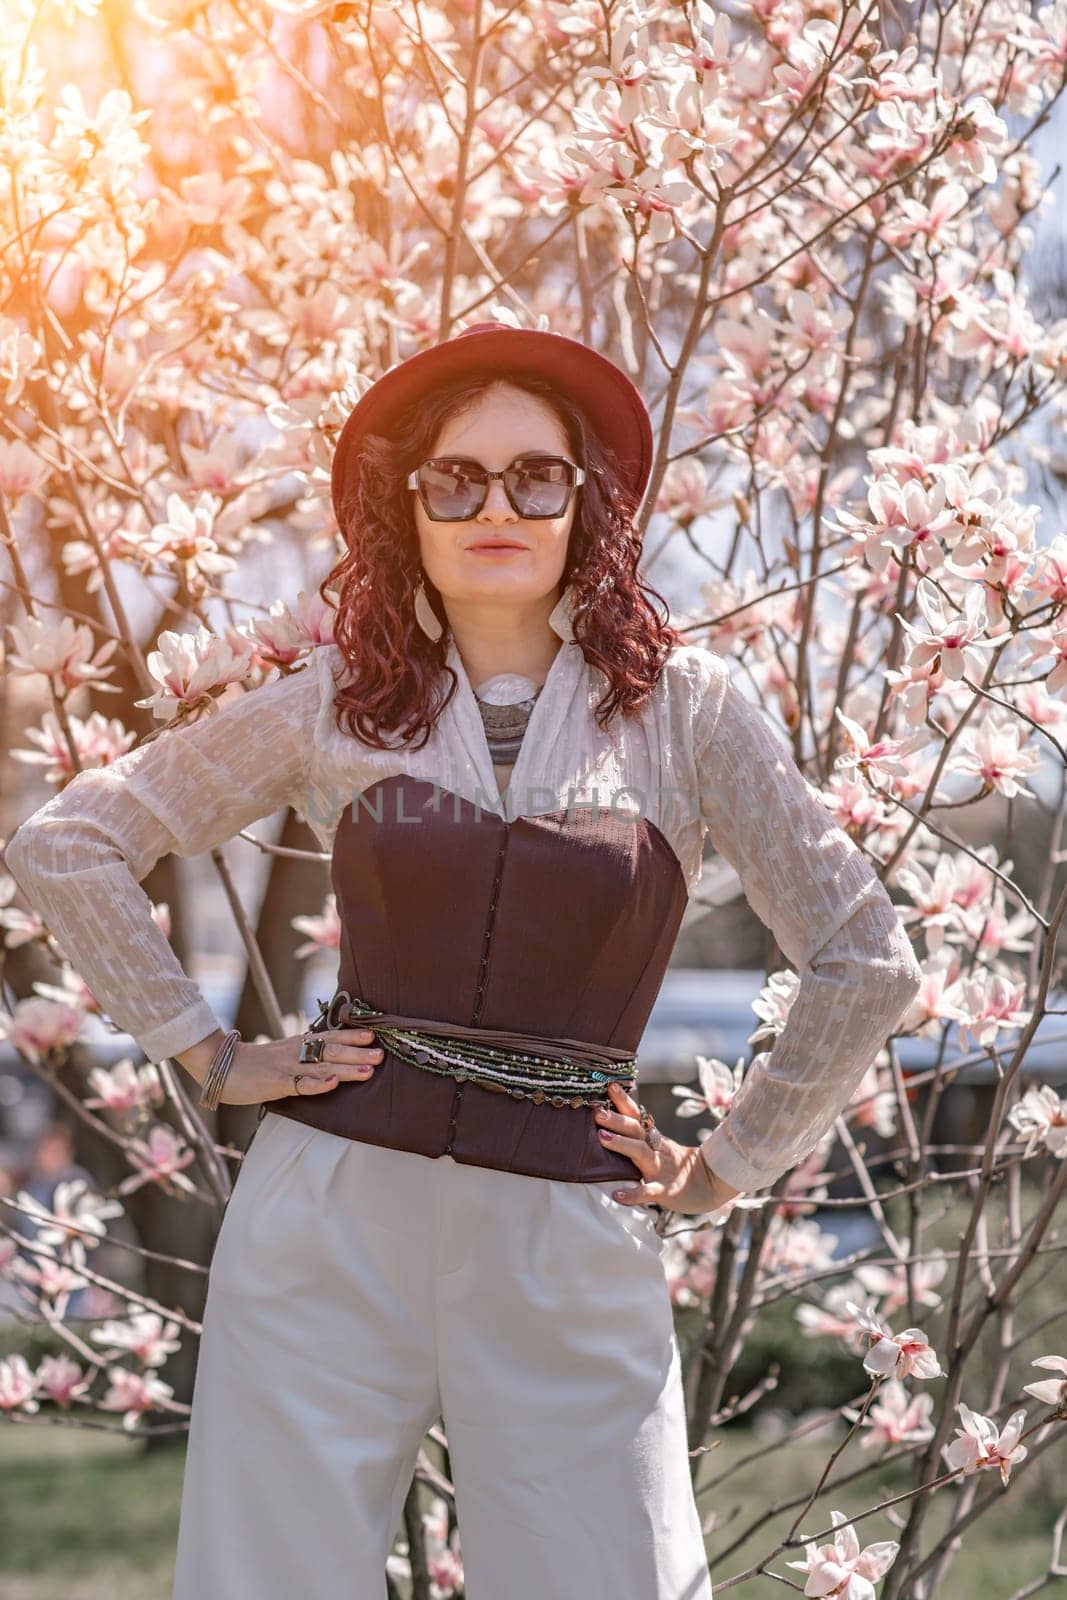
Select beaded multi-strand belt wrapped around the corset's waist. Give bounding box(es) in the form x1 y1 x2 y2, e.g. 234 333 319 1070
309 989 637 1107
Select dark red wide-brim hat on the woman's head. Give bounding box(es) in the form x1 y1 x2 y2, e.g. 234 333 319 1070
331 322 653 522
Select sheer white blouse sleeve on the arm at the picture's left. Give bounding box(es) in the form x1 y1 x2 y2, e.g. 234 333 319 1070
3 651 320 1061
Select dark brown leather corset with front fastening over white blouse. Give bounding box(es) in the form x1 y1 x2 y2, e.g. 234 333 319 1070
266 773 686 1182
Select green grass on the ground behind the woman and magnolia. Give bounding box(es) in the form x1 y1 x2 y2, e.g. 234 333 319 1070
0 1424 1062 1600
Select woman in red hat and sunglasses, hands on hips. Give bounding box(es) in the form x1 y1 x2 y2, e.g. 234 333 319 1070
6 323 920 1600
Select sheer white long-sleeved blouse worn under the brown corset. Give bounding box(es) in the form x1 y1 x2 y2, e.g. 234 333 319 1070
5 637 921 1190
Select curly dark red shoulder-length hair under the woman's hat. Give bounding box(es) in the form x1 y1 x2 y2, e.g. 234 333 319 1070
318 370 681 749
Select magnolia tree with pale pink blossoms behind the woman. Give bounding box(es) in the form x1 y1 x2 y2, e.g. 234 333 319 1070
0 0 1067 1600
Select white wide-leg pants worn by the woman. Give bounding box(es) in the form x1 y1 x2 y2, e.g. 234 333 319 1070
173 1112 712 1600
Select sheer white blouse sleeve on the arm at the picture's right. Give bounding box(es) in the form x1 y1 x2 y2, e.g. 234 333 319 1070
694 651 923 1190
